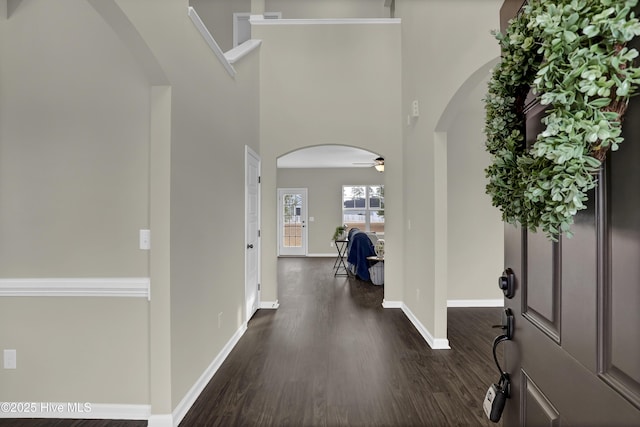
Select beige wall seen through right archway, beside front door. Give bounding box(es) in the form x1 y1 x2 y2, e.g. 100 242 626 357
447 79 504 300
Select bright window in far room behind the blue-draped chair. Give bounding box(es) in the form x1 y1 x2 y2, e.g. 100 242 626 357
342 185 384 233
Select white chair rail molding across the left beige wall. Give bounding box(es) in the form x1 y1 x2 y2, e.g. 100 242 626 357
0 277 151 300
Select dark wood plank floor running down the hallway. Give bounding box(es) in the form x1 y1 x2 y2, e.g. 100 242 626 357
0 258 500 427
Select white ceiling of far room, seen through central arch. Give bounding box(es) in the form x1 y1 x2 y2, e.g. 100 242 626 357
278 145 378 168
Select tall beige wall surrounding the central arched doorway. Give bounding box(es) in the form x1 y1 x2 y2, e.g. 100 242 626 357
252 19 403 301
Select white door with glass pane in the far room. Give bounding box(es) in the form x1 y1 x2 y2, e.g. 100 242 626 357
278 188 307 256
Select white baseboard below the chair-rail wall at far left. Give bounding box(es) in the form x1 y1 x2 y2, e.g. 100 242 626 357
0 402 151 420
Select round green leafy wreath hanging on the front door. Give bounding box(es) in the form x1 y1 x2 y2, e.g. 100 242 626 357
485 0 640 239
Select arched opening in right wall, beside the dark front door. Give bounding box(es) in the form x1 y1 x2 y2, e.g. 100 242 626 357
434 58 504 324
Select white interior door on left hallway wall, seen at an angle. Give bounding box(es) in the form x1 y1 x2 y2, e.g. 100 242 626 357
245 147 260 322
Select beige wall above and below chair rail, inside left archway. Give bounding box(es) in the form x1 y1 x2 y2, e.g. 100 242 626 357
0 0 149 404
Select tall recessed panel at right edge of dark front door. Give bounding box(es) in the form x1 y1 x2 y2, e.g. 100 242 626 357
598 150 640 408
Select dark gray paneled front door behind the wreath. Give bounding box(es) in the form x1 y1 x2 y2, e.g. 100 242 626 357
501 14 640 427
